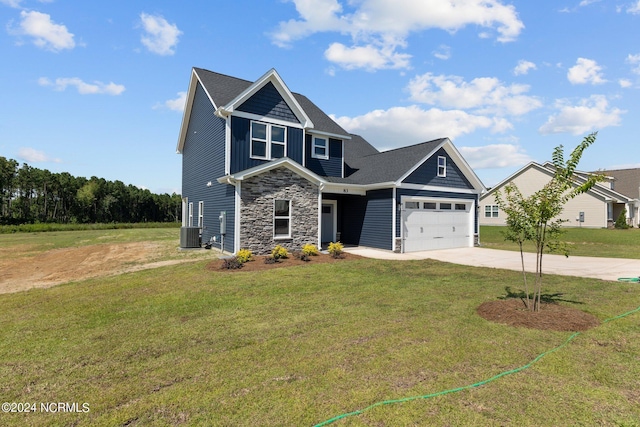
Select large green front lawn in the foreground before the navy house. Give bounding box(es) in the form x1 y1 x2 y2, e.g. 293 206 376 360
0 232 640 426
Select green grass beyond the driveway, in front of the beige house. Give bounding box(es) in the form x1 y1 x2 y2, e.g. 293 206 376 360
480 225 640 259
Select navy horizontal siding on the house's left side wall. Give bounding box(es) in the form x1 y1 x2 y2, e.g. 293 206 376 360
182 85 235 252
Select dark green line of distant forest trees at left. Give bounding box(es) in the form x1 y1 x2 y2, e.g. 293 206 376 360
0 156 182 225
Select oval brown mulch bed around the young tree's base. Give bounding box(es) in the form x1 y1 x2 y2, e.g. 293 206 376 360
477 298 600 331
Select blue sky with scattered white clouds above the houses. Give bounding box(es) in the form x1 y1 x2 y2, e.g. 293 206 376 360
0 0 640 193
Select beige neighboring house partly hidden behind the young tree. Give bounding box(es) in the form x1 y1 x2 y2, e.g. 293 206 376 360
480 162 638 228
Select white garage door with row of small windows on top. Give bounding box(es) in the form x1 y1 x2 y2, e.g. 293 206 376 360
402 199 473 252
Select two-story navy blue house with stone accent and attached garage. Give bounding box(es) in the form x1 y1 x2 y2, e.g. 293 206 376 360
177 68 484 254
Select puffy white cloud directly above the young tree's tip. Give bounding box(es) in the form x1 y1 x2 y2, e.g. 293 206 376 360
539 95 625 135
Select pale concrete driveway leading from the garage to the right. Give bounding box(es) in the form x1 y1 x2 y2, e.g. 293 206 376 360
344 247 640 280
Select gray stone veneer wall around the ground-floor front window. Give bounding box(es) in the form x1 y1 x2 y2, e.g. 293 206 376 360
240 167 319 255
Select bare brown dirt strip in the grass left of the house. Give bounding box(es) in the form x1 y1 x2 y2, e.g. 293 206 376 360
0 242 190 293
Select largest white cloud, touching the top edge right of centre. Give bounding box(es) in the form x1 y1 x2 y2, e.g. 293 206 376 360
271 0 524 69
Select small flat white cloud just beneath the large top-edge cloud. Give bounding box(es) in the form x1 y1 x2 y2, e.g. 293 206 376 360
324 43 411 71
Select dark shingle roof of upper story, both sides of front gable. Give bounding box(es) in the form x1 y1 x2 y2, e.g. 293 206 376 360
193 67 349 136
